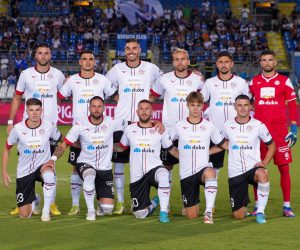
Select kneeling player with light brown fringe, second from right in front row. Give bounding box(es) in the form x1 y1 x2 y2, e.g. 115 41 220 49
164 92 225 224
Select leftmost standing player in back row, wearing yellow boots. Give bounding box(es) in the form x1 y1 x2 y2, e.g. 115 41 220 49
7 44 65 215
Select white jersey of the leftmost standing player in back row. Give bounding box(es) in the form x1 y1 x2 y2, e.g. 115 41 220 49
16 67 65 124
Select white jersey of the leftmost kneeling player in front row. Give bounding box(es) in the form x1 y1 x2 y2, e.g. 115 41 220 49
6 119 61 178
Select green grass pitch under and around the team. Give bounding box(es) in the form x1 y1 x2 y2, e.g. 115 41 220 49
0 126 300 249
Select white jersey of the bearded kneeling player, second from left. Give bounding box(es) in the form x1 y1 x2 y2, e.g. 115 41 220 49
65 116 116 170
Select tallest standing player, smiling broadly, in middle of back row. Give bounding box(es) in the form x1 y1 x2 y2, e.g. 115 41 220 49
107 39 160 214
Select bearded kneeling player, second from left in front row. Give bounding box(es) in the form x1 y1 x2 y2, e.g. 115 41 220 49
46 96 114 220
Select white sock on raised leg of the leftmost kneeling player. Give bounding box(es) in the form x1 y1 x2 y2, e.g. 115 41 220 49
42 171 55 214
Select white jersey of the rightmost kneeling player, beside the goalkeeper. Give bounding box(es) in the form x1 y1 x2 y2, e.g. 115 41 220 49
223 118 272 178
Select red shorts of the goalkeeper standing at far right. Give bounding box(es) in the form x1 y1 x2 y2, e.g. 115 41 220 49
260 124 293 166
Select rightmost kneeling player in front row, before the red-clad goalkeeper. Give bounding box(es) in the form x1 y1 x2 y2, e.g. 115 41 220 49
211 95 276 224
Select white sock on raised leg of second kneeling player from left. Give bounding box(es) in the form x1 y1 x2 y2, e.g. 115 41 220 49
83 175 96 213
